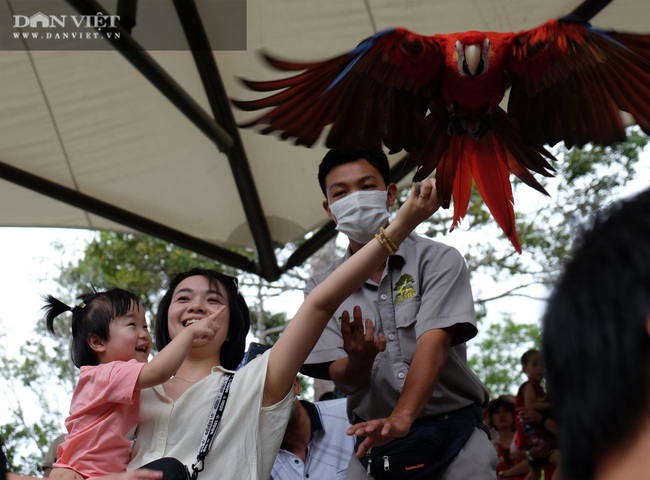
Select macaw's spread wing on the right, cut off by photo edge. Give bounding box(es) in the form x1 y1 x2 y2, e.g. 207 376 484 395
507 19 650 147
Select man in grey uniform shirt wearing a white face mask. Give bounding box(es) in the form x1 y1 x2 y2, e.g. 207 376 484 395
302 149 496 480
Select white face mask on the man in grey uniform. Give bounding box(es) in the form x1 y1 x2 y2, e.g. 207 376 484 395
330 190 389 244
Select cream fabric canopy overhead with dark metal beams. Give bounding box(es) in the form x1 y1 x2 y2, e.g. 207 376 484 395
0 0 650 280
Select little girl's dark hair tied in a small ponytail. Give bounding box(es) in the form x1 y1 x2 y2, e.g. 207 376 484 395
42 288 140 367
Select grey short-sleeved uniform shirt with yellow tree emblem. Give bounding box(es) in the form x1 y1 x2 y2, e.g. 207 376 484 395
305 234 488 423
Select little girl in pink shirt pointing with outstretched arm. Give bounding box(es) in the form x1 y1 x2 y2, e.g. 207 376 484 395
43 288 224 480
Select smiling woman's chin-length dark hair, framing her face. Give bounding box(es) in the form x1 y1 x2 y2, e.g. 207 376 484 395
154 268 251 370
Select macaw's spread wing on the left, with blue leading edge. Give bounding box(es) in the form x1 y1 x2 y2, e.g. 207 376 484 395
233 28 444 152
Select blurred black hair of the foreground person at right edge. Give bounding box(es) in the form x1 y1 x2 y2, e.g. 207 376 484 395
542 190 650 479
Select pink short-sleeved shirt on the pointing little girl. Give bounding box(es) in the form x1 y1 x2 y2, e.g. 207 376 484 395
54 360 145 478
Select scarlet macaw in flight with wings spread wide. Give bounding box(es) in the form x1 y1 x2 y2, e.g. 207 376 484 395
233 17 650 252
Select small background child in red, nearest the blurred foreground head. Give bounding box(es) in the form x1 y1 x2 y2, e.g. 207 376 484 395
515 349 559 480
